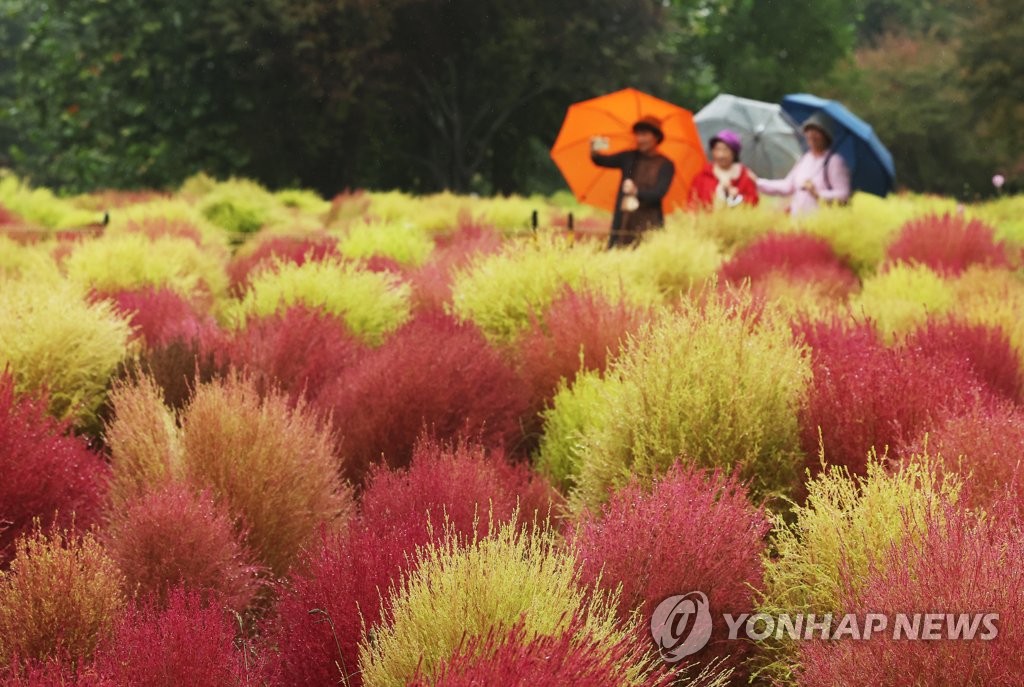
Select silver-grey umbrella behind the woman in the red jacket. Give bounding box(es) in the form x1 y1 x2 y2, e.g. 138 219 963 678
693 93 804 179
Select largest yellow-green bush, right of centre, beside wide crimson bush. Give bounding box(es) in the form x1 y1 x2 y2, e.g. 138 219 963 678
541 302 810 508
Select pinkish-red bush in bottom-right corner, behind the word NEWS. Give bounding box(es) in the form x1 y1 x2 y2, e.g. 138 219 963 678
798 505 1024 687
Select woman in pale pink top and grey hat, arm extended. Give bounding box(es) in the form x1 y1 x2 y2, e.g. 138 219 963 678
758 113 851 216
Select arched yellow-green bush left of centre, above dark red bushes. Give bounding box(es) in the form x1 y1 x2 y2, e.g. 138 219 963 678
228 260 411 344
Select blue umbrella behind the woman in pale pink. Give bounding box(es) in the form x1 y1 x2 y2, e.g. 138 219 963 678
782 93 896 198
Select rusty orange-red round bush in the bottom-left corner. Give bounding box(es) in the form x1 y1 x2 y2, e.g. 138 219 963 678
0 530 125 667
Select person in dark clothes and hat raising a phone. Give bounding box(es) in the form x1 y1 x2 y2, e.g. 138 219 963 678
590 117 676 248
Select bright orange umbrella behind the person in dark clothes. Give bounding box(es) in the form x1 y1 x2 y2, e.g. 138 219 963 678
551 88 707 213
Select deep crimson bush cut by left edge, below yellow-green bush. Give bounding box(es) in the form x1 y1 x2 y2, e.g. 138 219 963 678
0 372 109 567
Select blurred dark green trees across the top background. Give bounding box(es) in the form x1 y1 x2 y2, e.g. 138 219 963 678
0 0 1024 198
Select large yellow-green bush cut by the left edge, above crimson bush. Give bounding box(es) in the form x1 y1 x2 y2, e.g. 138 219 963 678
0 281 131 428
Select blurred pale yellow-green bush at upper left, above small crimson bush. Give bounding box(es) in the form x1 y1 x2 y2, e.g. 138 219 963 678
65 233 227 298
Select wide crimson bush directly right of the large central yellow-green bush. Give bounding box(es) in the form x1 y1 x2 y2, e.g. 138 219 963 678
798 320 992 474
